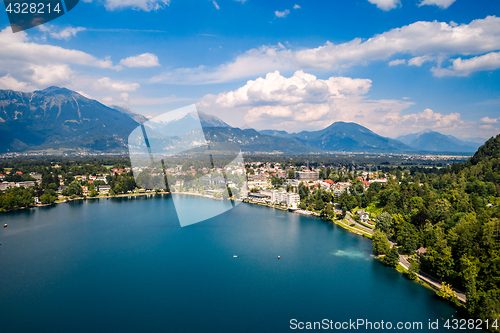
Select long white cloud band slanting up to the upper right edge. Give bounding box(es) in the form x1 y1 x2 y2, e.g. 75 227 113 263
153 16 500 84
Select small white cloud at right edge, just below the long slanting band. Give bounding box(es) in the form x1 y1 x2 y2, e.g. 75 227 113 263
431 52 500 77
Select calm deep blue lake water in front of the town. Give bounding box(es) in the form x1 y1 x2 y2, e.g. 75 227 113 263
0 195 474 332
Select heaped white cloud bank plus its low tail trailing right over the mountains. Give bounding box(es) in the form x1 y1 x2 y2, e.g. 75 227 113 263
197 71 495 137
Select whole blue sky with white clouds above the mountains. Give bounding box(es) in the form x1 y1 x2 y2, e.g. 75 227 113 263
0 0 500 138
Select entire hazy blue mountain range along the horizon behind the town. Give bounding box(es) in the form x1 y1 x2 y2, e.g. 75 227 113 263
0 87 488 154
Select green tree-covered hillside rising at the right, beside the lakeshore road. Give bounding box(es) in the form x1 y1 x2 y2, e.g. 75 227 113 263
339 135 500 321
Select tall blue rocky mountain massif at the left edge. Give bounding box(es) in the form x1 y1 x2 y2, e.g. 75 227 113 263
0 86 138 152
